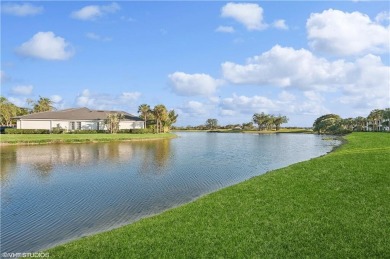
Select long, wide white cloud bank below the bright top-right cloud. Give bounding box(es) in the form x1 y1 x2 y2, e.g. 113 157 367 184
222 46 390 113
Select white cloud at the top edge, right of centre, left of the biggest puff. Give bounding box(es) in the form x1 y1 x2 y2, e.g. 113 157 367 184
221 3 267 30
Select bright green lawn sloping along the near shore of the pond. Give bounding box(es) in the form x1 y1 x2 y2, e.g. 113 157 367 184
47 133 390 258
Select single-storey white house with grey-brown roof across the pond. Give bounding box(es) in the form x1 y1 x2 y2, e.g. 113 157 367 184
14 107 144 131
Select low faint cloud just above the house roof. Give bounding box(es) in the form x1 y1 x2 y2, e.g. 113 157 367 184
76 89 141 110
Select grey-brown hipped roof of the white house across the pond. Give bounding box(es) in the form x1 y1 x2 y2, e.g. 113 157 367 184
14 107 142 121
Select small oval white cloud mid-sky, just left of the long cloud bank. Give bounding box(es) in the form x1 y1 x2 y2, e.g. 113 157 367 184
168 72 222 96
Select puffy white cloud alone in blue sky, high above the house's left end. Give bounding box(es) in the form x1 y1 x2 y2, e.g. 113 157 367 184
16 31 74 60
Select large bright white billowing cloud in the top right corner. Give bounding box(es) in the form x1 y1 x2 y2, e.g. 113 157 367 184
306 9 390 56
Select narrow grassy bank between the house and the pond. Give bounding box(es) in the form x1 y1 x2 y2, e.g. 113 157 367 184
0 133 175 144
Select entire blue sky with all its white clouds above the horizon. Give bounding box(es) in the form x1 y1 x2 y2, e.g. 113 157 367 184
0 1 390 127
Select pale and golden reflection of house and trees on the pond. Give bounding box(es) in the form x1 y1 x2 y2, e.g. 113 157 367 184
0 139 171 184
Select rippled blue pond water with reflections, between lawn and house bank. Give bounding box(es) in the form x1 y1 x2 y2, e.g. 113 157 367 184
1 132 340 253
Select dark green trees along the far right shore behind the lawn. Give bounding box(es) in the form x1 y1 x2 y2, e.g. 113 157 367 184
313 108 390 134
